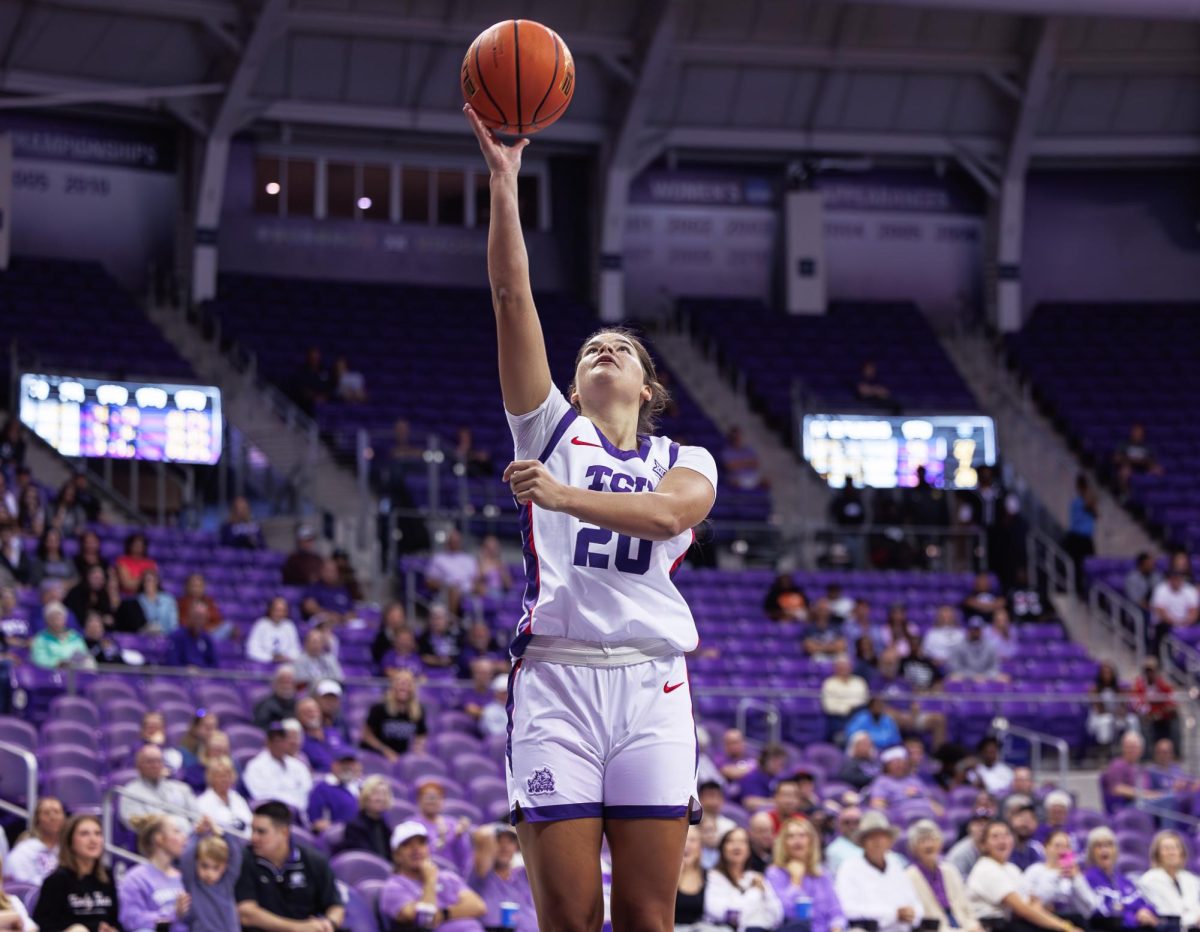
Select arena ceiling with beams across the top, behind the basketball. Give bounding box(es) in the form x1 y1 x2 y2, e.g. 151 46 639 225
0 0 1200 176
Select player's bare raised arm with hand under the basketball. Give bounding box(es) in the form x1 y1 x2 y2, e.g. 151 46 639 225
463 104 551 414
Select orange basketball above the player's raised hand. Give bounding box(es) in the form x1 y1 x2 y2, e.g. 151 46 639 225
462 19 575 136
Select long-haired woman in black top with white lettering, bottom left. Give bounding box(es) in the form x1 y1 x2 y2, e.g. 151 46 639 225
32 814 121 932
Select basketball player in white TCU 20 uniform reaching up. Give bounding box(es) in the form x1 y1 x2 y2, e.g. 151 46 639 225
464 98 716 932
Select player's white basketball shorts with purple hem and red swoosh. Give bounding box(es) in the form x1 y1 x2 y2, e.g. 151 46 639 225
505 655 700 824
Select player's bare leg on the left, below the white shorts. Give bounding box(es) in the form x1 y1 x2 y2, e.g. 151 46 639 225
517 818 604 932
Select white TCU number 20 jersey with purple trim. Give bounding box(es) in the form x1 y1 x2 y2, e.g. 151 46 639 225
508 386 716 657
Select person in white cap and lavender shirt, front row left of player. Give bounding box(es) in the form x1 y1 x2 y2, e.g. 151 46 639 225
379 822 487 932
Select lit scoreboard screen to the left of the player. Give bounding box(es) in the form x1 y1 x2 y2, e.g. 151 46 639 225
19 373 222 465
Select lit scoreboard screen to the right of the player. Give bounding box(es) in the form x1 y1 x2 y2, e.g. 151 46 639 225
802 414 996 488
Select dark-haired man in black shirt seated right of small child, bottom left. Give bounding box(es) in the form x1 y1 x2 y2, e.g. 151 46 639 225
234 802 346 930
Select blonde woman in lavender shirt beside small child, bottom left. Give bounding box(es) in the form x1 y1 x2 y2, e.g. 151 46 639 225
116 816 192 932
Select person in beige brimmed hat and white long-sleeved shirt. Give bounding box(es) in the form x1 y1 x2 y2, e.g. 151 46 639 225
834 812 924 932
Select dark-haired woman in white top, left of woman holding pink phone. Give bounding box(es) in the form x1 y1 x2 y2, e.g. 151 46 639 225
967 820 1079 932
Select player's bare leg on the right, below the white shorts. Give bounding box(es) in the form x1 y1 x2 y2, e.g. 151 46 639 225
605 817 688 932
